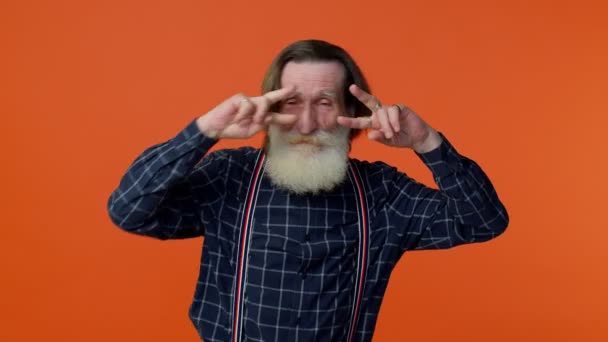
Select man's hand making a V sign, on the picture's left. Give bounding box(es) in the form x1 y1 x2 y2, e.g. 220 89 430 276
196 87 297 139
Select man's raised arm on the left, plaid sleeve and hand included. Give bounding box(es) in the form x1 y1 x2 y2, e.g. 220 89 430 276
108 88 296 239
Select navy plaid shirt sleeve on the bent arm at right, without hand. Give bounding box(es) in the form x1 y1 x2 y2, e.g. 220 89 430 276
388 137 509 250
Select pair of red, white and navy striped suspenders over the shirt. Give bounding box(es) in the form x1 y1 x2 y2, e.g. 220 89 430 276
232 151 369 342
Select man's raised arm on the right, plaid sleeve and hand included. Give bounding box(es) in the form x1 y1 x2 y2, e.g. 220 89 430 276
338 85 509 250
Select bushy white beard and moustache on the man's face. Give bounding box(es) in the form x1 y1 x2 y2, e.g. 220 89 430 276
266 125 350 194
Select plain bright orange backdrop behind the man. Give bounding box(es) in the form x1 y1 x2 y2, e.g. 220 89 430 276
0 0 608 342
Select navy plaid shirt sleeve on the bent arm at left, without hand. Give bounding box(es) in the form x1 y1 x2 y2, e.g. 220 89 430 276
108 121 221 239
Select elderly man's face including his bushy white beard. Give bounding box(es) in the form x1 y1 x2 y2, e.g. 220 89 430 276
267 62 350 193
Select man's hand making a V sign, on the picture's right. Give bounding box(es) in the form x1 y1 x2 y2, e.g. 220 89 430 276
338 84 442 153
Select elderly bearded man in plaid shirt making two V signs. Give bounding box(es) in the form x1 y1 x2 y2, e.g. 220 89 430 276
108 40 508 342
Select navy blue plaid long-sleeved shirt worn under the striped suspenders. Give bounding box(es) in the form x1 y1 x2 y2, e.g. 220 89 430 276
108 122 508 342
